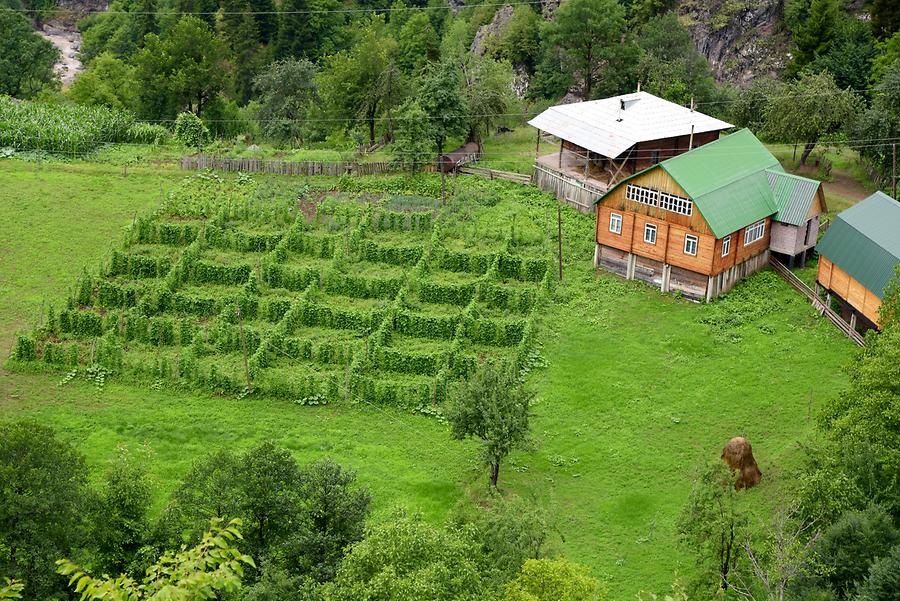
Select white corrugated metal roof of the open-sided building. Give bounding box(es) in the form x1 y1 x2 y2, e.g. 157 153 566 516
528 92 732 158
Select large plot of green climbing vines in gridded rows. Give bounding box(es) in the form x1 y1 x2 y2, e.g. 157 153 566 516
12 174 555 413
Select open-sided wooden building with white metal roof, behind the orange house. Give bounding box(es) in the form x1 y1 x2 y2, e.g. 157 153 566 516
528 92 732 212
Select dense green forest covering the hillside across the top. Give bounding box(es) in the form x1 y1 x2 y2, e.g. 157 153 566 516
0 0 900 172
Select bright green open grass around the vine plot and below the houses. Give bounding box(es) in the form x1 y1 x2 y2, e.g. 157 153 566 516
0 161 854 599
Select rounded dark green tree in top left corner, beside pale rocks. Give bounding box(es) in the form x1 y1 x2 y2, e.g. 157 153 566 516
0 6 59 99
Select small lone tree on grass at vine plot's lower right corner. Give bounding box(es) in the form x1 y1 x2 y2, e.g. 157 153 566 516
447 363 532 488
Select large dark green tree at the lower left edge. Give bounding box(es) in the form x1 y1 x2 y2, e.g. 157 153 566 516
0 422 87 599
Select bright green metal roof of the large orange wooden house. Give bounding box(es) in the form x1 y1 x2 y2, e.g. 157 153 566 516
595 129 781 238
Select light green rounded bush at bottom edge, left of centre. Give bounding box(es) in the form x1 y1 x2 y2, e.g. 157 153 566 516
323 515 486 601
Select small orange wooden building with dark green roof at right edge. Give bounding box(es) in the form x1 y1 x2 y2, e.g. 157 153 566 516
816 192 900 328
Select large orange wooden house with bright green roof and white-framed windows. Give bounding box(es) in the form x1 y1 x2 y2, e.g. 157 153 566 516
594 129 824 301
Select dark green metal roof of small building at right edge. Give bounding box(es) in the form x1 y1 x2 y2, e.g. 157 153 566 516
816 192 900 298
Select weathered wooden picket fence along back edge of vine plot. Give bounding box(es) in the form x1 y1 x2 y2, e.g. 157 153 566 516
181 155 403 176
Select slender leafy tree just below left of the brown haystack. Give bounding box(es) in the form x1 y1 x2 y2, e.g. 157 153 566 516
678 461 747 598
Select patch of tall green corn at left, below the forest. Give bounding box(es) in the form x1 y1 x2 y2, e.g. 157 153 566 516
0 97 168 155
